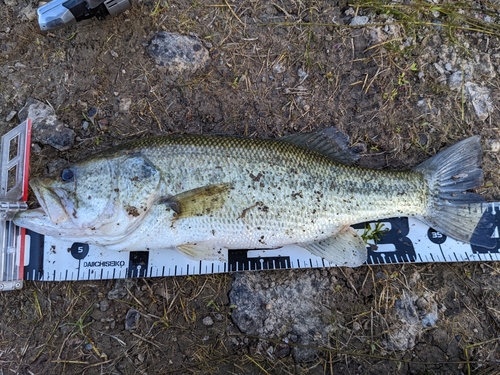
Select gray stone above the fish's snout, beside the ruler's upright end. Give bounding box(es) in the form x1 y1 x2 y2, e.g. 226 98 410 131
18 98 75 151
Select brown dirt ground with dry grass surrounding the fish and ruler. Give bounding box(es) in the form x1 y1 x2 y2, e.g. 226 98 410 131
0 0 500 374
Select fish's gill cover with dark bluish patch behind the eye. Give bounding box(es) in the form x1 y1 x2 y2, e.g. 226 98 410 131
116 155 161 217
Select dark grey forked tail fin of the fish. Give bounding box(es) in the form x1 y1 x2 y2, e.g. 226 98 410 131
414 136 496 248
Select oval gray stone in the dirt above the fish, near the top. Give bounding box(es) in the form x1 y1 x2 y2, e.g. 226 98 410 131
147 31 210 75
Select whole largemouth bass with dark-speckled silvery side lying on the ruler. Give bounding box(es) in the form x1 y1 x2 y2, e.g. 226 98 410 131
14 129 494 266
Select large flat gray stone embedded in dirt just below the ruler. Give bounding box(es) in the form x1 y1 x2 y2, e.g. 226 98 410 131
229 270 333 362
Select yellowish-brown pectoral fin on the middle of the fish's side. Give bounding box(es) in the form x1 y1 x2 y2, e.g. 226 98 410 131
158 183 231 219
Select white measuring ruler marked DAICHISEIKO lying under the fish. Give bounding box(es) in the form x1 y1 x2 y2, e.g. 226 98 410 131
0 123 500 290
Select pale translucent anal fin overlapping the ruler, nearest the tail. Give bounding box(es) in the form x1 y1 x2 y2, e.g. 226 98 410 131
299 227 368 267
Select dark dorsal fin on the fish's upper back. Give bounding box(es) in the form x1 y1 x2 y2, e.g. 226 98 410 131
279 126 361 165
